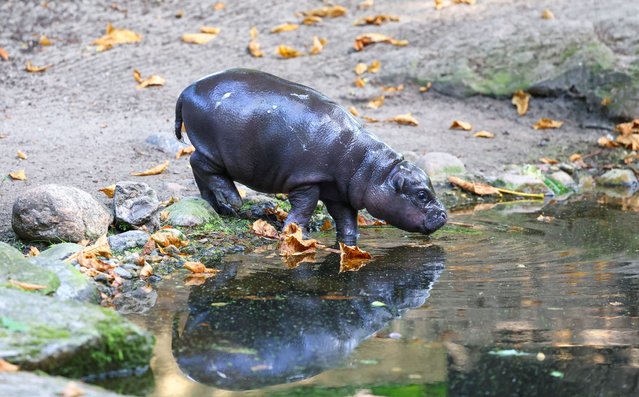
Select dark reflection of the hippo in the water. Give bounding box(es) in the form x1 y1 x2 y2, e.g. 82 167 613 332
173 246 445 390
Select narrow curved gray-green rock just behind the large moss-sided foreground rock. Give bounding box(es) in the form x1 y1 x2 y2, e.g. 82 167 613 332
28 255 100 304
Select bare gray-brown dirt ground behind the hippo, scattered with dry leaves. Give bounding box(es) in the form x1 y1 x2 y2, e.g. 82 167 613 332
0 0 612 240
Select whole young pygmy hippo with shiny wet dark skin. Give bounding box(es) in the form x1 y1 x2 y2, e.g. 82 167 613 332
175 69 447 245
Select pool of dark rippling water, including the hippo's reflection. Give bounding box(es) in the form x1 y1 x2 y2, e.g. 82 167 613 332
102 200 639 397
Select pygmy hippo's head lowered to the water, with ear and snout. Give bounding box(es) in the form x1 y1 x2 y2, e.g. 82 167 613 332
364 161 448 234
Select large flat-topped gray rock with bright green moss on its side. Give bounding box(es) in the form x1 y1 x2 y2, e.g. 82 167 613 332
0 288 154 378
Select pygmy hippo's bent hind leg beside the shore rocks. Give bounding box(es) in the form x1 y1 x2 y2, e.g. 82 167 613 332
190 150 242 216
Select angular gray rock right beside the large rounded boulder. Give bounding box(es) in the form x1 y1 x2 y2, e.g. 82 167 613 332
113 181 160 231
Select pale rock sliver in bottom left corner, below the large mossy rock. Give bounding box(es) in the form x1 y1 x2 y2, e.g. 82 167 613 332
0 371 132 397
